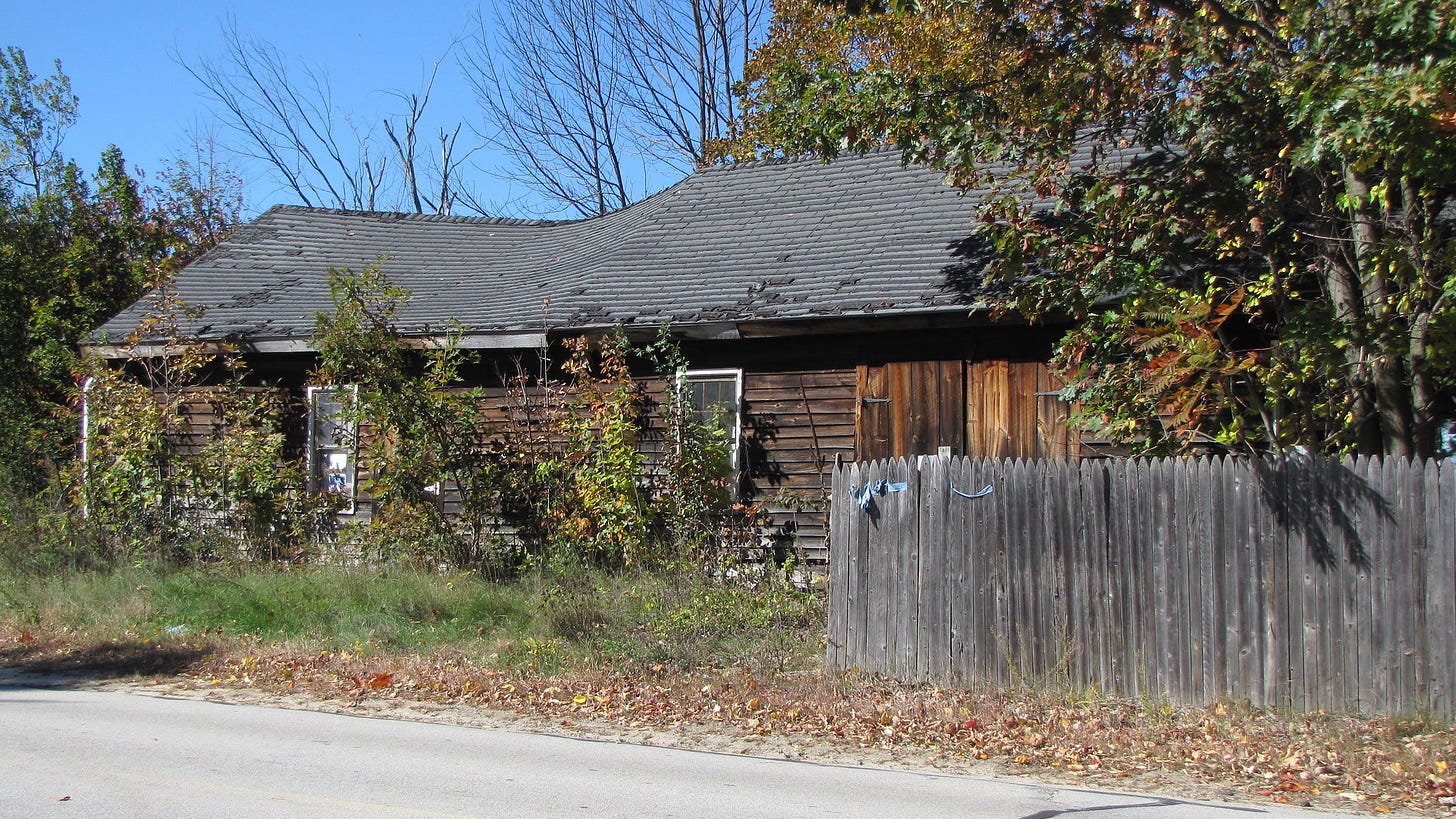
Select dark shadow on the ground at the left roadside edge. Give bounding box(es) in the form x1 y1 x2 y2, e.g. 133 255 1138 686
0 640 211 688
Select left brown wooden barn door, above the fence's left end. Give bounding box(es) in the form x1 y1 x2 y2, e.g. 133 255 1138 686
855 361 965 461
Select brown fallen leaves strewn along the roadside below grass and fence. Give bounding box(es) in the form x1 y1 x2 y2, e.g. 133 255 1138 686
0 631 1456 816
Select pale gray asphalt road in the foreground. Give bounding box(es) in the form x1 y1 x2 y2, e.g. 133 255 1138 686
0 681 1351 819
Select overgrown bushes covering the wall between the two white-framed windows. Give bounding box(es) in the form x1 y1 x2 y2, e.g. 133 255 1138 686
314 265 768 574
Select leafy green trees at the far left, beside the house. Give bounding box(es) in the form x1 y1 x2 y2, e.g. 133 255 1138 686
0 47 242 488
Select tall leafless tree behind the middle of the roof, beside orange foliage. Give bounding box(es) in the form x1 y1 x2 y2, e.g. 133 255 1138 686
462 0 769 216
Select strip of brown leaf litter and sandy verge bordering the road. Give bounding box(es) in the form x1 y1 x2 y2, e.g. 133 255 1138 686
0 630 1456 816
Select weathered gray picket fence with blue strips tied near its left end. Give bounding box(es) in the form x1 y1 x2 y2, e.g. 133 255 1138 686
828 455 1456 714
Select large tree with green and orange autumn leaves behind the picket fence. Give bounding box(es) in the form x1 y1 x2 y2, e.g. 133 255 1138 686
725 0 1456 455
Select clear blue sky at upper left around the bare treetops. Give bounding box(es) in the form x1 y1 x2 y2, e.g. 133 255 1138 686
8 0 585 214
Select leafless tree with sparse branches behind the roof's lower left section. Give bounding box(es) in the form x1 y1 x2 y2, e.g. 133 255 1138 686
181 20 476 213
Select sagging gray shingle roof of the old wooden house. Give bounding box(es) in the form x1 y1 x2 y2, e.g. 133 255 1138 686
92 150 1112 344
